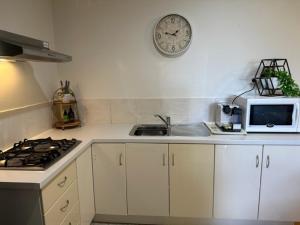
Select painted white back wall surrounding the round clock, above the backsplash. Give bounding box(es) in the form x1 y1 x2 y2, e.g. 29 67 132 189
54 0 300 98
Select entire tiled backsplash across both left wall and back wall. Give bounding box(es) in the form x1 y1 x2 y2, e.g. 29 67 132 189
0 98 230 149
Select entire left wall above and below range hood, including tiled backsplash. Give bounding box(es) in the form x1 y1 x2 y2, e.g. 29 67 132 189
0 0 58 150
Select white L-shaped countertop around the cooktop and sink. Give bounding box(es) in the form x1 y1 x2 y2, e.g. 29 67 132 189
0 124 300 189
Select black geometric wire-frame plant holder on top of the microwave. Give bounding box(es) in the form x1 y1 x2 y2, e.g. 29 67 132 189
253 59 291 96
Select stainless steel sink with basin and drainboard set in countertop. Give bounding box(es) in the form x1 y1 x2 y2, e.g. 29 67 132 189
129 123 210 137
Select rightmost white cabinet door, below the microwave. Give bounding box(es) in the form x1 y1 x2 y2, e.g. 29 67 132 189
259 145 300 221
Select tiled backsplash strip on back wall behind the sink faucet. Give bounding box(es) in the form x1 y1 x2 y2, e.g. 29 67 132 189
79 98 230 125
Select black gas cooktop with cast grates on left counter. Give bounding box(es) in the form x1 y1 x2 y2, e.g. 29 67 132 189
0 137 81 170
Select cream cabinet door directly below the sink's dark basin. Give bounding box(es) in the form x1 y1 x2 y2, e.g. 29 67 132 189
126 144 169 216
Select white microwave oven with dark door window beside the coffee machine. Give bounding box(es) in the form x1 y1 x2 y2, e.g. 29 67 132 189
236 96 300 132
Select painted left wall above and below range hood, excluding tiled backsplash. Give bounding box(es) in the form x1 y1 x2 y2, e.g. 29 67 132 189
0 0 58 111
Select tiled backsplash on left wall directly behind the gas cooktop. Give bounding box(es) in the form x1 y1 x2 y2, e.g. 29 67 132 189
0 105 52 150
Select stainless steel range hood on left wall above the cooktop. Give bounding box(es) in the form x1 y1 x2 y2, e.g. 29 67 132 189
0 30 72 62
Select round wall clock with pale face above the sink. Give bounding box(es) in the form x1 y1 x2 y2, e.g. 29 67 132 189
154 14 192 57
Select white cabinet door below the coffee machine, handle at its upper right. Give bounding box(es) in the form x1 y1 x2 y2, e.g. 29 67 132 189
214 145 262 220
